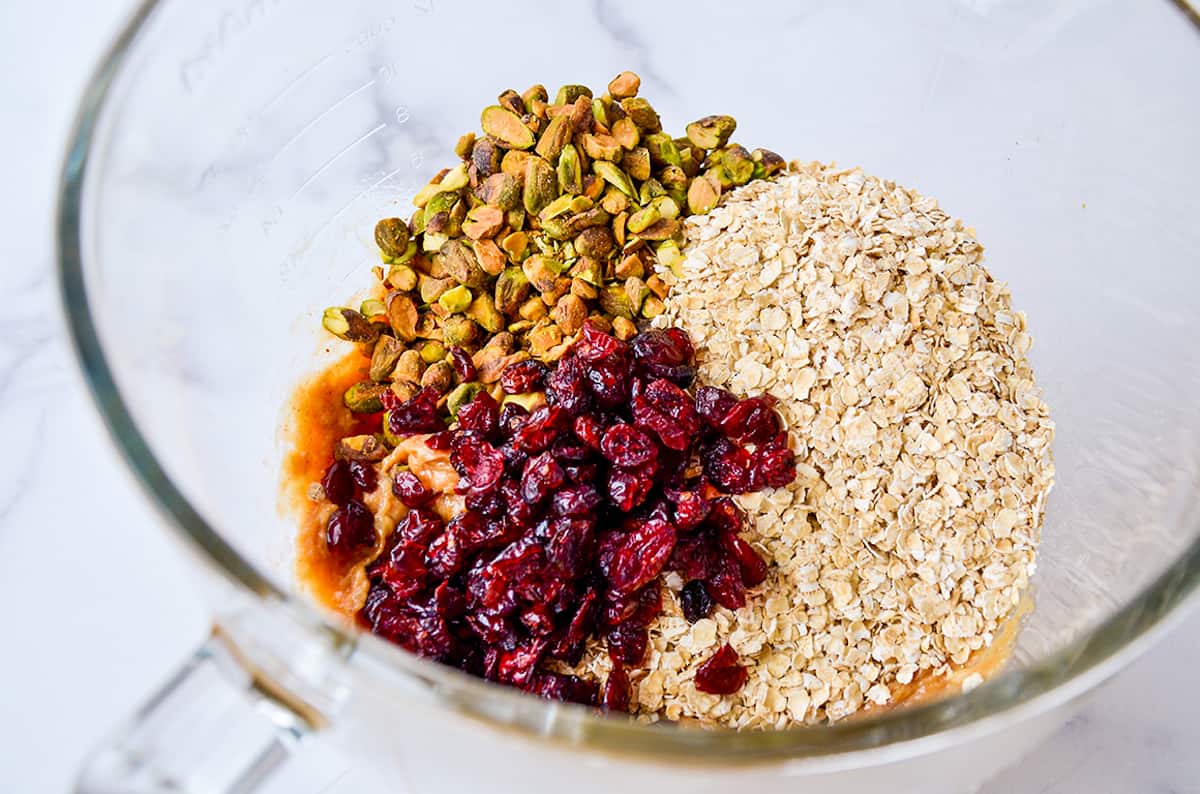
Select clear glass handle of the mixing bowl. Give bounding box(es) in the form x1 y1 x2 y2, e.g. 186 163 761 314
76 604 344 794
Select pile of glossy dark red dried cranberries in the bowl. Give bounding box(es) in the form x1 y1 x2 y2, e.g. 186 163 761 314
329 324 796 710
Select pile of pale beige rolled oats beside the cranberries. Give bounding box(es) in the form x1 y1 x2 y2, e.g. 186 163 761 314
628 163 1054 728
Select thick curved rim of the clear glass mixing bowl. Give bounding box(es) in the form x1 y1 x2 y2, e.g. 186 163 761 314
55 0 1200 764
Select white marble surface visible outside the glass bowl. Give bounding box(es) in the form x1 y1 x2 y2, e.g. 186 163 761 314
0 0 1200 794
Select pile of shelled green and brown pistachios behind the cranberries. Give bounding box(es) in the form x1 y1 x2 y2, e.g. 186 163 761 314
323 72 785 411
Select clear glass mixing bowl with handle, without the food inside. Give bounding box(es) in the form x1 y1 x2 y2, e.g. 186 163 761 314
58 0 1200 792
